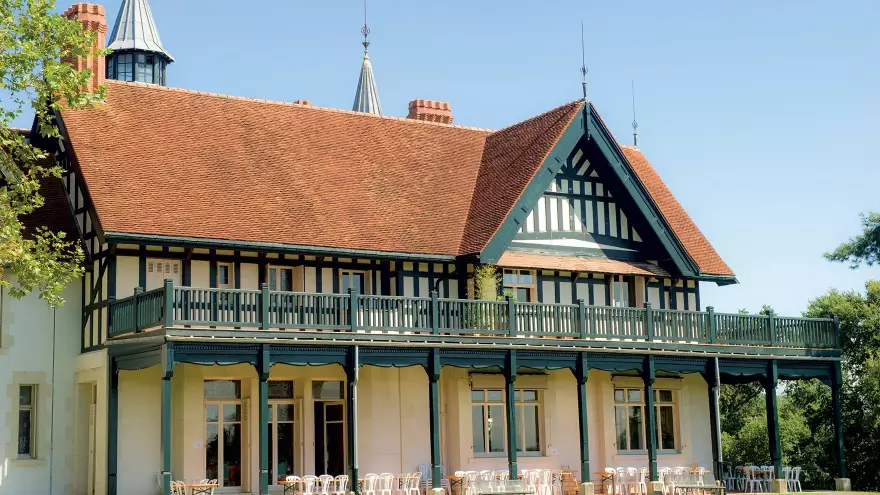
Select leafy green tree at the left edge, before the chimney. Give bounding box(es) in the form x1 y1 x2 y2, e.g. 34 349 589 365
0 0 104 306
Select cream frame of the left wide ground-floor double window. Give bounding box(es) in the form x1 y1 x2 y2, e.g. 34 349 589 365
470 388 545 458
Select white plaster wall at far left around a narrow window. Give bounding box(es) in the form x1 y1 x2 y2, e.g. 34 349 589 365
0 280 82 495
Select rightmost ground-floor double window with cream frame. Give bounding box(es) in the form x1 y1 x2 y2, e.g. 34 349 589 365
614 388 676 451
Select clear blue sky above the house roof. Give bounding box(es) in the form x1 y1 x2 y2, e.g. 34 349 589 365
25 0 880 315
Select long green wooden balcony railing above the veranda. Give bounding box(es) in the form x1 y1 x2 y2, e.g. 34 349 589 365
109 281 839 349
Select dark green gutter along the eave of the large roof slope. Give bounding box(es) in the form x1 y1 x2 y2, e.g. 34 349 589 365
104 232 456 261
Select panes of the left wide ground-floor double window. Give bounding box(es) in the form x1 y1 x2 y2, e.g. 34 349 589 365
471 390 542 456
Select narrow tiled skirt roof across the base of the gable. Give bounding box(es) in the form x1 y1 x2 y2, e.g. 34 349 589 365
497 251 670 277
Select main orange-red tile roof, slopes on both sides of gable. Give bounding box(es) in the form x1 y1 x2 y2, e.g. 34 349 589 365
62 80 729 273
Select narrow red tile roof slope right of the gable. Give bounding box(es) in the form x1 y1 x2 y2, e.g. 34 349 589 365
621 146 733 276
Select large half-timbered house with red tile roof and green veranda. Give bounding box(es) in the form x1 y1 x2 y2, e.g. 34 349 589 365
0 0 845 495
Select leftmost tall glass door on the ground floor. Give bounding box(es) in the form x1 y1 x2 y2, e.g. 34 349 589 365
205 380 245 487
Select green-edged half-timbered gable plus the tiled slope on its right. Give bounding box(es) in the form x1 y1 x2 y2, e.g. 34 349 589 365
480 105 736 284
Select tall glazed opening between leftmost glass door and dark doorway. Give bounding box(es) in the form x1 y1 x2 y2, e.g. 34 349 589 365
269 380 296 485
